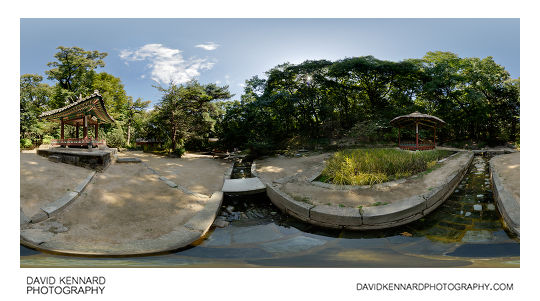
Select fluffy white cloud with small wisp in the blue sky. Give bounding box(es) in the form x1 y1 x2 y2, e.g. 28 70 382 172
120 44 215 84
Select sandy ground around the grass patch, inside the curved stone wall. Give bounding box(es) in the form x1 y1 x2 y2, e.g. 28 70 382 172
257 154 467 208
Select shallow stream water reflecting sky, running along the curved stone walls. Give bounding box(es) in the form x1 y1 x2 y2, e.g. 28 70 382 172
20 156 520 267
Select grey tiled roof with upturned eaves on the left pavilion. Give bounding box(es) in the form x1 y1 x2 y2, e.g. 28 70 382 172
39 90 115 123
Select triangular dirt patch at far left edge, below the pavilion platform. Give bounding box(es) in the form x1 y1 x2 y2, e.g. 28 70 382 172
20 151 91 217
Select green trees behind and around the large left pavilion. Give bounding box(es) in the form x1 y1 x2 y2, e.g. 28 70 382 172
20 46 150 148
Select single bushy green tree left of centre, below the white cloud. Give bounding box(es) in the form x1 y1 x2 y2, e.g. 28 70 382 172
156 81 231 151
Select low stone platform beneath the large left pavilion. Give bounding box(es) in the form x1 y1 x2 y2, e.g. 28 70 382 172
37 147 117 171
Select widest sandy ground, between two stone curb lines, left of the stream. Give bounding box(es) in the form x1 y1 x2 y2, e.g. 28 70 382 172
23 164 205 252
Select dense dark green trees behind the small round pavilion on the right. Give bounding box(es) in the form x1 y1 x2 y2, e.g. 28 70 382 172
216 52 519 149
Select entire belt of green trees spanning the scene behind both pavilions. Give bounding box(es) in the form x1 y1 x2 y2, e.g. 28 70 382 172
20 46 520 154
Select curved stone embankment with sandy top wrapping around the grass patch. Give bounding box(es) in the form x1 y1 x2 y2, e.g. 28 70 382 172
256 152 474 230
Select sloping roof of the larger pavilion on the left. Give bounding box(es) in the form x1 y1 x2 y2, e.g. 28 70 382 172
39 90 114 125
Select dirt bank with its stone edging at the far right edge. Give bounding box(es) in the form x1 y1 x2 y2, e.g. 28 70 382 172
489 152 520 236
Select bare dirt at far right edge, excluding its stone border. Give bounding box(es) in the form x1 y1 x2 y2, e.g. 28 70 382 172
492 152 520 203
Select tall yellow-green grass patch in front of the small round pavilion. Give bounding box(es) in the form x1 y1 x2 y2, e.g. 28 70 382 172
318 148 453 185
